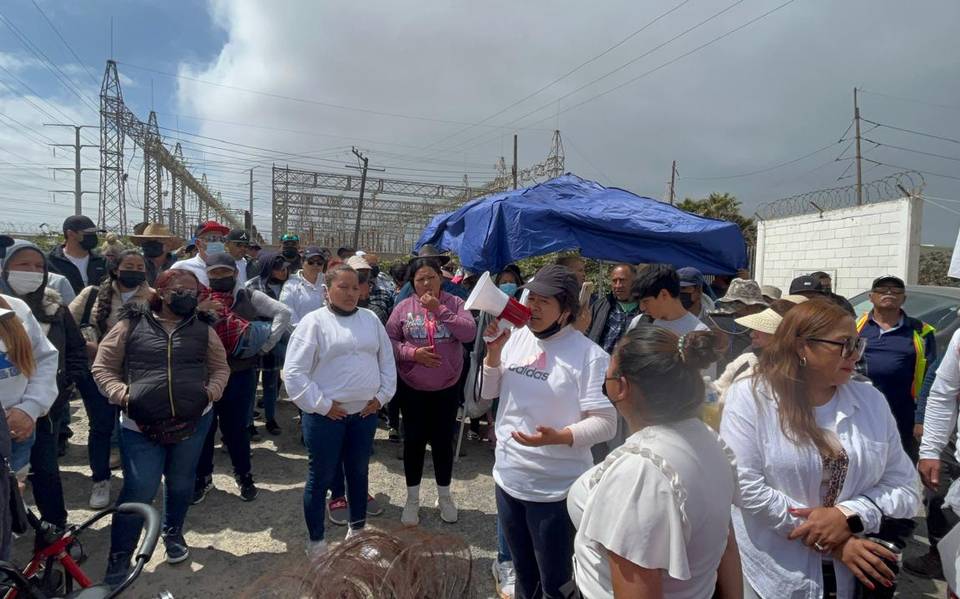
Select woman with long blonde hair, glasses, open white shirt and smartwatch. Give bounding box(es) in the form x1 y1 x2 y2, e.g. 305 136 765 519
720 299 920 599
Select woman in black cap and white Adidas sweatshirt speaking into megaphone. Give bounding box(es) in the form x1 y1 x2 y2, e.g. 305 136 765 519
480 264 617 597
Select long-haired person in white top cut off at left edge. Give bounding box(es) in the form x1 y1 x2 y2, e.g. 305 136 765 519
0 295 58 472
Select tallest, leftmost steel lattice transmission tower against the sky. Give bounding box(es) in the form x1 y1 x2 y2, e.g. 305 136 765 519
97 60 127 235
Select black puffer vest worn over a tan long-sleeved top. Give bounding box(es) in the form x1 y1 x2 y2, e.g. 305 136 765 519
122 304 210 424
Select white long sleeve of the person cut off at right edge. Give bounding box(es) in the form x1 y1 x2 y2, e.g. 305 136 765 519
920 331 960 511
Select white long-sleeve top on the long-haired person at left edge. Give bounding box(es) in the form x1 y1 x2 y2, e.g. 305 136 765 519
0 295 60 421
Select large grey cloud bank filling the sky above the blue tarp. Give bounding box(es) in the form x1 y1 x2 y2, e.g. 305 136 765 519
158 0 960 247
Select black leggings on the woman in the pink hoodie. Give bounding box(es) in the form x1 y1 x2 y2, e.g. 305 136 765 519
397 380 459 487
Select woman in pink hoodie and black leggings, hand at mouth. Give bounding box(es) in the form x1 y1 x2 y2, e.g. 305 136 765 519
387 258 477 526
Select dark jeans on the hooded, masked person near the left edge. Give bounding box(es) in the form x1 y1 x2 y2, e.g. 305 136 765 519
30 406 68 527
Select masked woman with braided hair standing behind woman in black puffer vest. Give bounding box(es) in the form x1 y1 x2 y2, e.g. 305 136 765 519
70 249 154 509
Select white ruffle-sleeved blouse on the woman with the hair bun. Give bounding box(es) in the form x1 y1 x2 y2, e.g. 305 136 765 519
567 418 737 599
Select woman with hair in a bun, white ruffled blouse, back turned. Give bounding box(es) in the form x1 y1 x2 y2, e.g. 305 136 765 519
567 326 742 599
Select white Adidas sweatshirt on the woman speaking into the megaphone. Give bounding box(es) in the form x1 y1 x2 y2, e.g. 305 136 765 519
493 326 610 503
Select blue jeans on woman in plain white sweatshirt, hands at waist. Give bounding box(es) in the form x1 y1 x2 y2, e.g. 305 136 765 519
300 413 378 541
